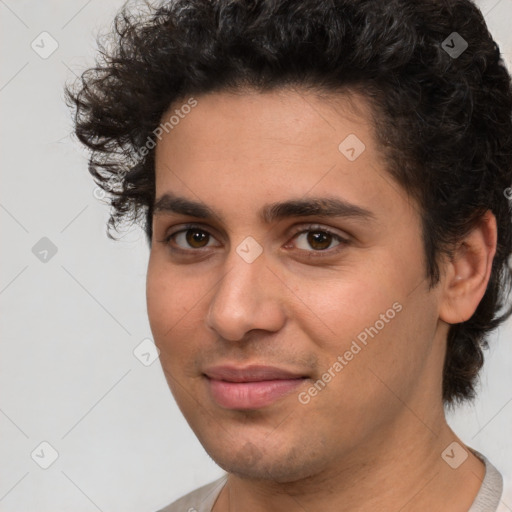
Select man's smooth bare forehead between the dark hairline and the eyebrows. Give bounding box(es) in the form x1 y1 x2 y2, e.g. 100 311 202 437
155 90 416 228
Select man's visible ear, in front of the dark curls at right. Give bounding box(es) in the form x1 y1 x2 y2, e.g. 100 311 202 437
439 210 498 324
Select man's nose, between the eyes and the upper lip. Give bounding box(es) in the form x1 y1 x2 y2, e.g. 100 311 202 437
206 243 286 341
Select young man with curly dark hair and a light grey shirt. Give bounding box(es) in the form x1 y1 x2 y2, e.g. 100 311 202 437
69 0 512 512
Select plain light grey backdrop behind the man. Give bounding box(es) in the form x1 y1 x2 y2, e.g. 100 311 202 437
0 0 512 512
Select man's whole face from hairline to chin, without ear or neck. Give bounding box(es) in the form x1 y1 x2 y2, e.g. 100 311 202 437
147 89 443 482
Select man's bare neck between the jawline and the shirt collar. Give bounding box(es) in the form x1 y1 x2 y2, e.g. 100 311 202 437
213 408 485 512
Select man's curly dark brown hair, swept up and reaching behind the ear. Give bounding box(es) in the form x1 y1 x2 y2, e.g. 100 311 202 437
66 0 512 406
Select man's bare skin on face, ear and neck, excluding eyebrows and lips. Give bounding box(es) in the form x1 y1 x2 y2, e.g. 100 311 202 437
147 89 496 512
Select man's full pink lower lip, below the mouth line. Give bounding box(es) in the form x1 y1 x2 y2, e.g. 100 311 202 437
207 378 306 409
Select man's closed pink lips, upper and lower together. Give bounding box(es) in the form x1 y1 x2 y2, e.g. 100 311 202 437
204 366 308 410
